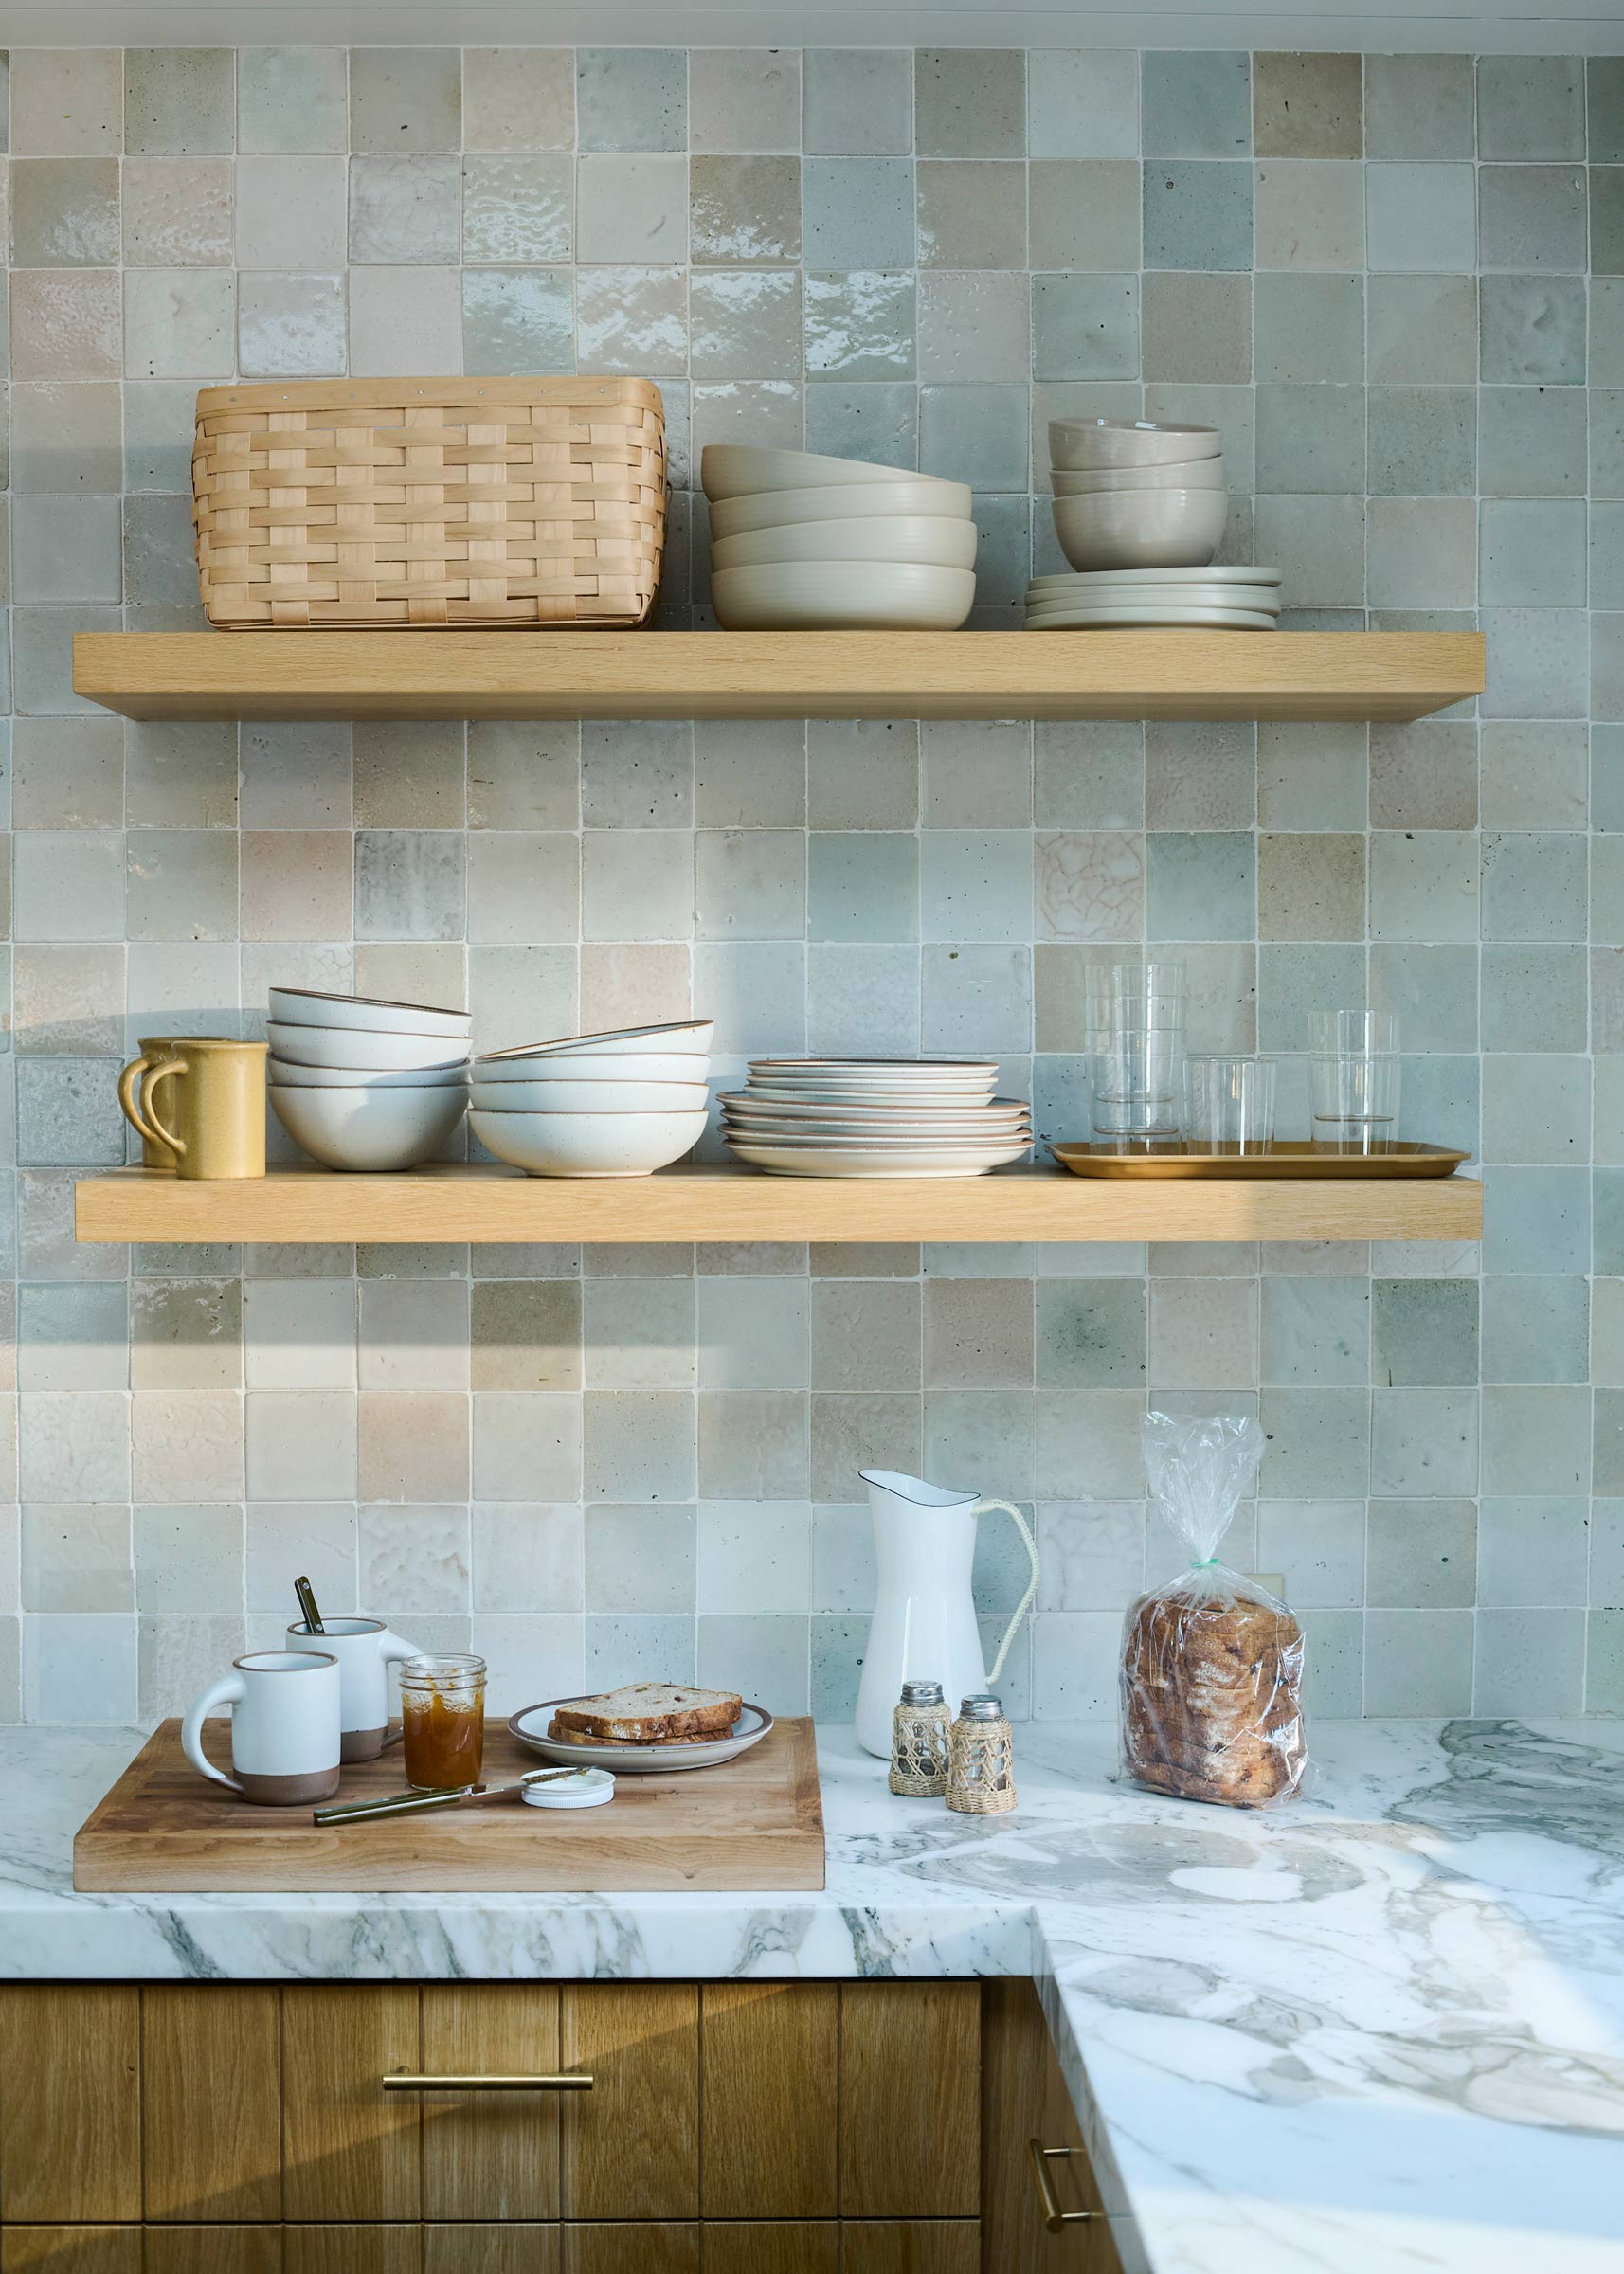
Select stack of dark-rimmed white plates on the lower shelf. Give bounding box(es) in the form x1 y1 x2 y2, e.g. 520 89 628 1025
721 1057 1033 1176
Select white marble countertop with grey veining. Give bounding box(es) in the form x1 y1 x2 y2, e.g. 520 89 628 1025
0 1722 1624 2274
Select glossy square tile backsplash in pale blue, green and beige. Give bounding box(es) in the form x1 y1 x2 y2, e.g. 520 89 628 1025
0 47 1624 1722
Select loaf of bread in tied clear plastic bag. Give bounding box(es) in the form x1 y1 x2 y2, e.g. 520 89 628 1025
1121 1412 1308 1808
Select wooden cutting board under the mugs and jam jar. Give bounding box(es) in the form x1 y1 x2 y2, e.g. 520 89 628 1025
73 1719 823 1894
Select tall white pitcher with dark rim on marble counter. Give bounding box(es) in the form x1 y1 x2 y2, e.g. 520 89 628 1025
857 1469 1038 1760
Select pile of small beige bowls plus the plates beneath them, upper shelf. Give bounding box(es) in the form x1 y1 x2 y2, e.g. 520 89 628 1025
1026 419 1281 632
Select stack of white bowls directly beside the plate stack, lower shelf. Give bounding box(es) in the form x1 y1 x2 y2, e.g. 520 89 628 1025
469 1019 714 1176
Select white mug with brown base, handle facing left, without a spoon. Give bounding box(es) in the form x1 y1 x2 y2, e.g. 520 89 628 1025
180 1651 339 1808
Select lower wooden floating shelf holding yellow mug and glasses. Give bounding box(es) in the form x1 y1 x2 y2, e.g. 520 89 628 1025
75 1164 1483 1241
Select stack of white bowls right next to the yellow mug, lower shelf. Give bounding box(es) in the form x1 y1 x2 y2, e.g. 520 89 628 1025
266 987 473 1173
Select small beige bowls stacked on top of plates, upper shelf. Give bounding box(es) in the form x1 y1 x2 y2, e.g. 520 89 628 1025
1049 419 1228 568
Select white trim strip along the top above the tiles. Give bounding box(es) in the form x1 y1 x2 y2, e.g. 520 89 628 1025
0 0 1624 55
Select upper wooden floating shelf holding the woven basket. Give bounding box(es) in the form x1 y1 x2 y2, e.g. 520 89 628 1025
73 630 1483 718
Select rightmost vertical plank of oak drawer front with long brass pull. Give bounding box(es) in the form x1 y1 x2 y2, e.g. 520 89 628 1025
839 1983 981 2219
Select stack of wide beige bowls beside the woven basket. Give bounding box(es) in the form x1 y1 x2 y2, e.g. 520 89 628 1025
698 443 976 632
